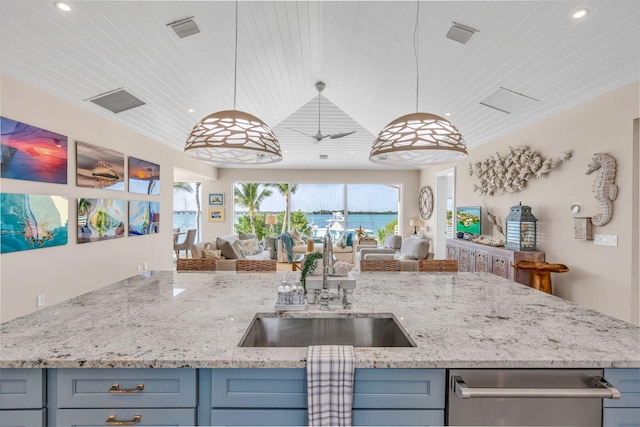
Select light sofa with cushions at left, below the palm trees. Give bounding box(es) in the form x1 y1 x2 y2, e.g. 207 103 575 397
191 233 271 271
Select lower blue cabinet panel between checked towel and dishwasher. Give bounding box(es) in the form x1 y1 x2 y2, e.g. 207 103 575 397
352 409 444 426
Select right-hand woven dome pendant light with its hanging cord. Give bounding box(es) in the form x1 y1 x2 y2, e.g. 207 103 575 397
369 1 468 167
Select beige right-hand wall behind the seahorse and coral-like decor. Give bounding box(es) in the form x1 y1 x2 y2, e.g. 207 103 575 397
420 83 640 324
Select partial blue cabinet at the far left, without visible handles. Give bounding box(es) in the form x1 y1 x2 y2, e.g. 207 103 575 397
0 369 47 427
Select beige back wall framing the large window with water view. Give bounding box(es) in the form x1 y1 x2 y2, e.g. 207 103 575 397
202 169 420 244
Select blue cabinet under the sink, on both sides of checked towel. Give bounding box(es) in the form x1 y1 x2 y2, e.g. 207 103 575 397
198 369 446 426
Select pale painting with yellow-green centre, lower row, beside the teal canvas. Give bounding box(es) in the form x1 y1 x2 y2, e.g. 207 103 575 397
78 199 127 243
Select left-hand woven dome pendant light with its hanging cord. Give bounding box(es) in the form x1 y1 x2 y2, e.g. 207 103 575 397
184 1 282 164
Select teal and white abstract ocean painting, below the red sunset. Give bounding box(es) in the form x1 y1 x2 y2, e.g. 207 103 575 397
0 193 69 254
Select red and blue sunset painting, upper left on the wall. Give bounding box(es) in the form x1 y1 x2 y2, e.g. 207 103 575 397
0 117 68 184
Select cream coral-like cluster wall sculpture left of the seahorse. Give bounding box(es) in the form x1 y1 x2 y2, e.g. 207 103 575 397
469 146 573 196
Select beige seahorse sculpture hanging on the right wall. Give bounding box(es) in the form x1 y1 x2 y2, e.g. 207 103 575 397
586 153 618 226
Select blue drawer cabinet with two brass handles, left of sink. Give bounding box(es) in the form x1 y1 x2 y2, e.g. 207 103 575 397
48 369 197 426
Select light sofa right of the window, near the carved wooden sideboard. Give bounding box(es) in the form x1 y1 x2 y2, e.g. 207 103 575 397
356 234 433 271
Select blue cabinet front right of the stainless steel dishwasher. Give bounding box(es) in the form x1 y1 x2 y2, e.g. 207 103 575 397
602 368 640 427
